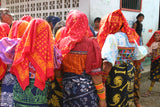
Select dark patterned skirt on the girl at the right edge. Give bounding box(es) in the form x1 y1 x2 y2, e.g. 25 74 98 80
150 58 160 82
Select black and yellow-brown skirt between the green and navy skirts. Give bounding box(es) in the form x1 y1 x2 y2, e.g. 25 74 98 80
48 78 63 107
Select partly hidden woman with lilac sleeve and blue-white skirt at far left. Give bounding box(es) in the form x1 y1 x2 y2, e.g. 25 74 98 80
0 20 28 107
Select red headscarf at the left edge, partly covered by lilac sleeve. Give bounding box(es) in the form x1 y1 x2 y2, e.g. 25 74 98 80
0 23 10 80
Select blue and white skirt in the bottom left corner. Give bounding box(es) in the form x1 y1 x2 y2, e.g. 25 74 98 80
1 72 16 107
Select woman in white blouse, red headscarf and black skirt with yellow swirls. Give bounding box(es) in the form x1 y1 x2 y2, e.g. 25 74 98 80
97 9 147 107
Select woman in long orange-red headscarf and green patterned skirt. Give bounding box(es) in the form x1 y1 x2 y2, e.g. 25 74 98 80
8 19 61 107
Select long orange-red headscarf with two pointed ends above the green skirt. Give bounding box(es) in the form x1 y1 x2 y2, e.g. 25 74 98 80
11 19 54 90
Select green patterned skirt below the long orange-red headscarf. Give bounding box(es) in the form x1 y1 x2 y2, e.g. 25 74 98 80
13 79 48 107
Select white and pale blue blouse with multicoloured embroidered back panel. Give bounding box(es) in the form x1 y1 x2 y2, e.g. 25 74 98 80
101 32 147 66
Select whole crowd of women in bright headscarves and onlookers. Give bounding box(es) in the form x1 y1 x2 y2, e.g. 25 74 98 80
0 9 160 107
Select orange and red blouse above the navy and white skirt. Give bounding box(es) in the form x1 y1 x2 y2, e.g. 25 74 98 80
62 37 102 75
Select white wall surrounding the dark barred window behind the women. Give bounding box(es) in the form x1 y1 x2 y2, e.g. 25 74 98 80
90 0 159 44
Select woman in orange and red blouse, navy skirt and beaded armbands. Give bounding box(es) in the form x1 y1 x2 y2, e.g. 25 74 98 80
57 10 106 107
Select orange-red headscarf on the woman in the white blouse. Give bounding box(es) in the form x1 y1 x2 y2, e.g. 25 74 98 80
97 9 139 48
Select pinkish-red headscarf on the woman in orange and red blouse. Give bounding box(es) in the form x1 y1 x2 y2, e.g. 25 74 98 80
58 10 93 57
